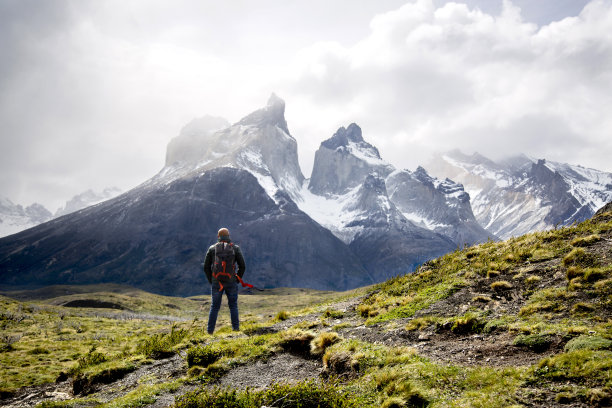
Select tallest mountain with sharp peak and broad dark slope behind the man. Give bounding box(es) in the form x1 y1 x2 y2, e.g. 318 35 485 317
0 96 368 295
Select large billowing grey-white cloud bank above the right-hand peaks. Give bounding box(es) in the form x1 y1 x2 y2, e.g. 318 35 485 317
291 0 612 171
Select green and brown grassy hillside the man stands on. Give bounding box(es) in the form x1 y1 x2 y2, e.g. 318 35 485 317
0 206 612 408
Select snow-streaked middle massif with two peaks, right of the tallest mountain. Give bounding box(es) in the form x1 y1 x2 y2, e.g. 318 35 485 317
296 123 493 249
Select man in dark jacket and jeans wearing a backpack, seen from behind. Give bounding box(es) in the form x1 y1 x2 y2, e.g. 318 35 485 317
204 228 246 334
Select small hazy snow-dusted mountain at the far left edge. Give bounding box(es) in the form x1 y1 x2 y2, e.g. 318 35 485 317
0 197 53 237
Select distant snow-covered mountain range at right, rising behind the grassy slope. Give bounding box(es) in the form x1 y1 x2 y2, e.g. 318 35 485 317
427 151 612 239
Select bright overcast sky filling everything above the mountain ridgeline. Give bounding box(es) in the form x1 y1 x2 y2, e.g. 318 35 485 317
0 0 612 211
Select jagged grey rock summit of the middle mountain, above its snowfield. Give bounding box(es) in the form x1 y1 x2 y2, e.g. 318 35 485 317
308 123 393 195
